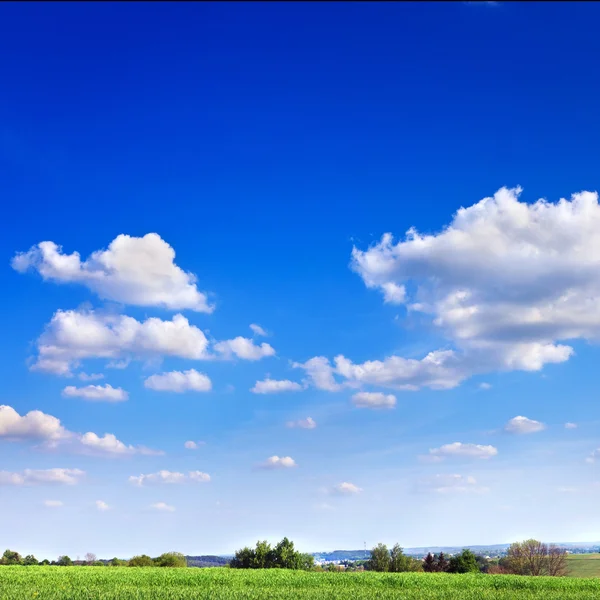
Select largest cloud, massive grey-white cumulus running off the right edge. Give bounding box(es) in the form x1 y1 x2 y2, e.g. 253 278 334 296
337 188 600 389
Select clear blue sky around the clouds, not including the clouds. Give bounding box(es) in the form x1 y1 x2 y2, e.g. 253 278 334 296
0 2 600 557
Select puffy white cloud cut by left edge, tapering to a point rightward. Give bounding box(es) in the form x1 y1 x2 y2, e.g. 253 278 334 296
0 406 163 456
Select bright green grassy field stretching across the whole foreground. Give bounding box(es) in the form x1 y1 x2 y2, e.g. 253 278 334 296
0 567 600 600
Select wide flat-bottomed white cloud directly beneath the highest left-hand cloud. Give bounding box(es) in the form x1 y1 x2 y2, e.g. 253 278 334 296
32 310 210 376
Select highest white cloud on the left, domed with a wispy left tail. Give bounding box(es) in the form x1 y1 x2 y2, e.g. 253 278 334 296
11 233 214 313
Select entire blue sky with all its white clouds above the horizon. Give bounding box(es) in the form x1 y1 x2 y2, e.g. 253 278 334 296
0 2 600 557
